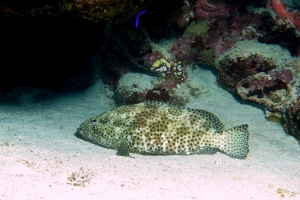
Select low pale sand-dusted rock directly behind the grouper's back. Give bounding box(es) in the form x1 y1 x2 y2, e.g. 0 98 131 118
111 68 207 106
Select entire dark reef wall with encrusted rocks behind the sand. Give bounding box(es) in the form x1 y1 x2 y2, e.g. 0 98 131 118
0 0 300 141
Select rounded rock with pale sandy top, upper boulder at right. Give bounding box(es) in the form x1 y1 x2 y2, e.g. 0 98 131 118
215 40 291 92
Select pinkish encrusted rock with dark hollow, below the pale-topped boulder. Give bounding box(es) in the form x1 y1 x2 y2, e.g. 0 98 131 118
236 69 293 119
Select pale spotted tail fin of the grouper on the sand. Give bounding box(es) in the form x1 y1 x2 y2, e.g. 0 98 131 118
215 124 249 159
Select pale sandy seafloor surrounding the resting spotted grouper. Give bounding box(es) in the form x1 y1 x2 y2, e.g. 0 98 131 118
0 66 300 200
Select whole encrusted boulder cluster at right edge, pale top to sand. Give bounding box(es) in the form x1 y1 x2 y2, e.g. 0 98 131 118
216 40 300 139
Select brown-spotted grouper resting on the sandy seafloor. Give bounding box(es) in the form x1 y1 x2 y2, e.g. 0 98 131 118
77 101 249 159
